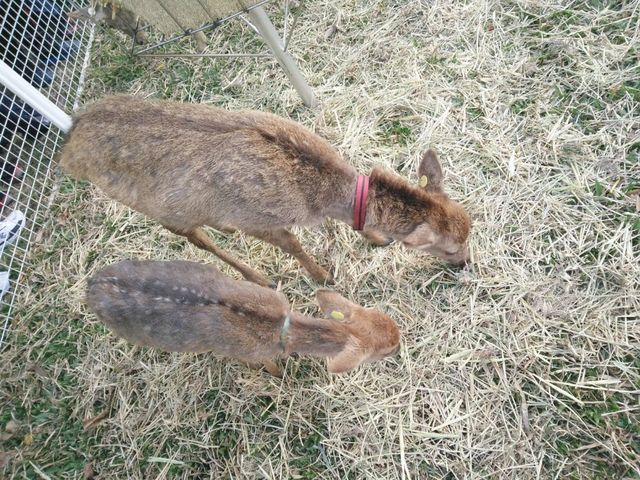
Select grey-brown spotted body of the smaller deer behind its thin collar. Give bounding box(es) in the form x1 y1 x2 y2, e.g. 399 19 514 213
87 260 288 359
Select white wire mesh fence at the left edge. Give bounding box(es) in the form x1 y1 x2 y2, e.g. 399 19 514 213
0 0 93 345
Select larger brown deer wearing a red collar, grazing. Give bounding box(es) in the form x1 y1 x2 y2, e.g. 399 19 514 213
61 96 470 285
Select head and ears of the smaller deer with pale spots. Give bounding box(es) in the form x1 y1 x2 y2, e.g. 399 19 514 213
316 289 400 373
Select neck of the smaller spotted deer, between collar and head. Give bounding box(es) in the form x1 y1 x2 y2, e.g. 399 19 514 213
285 312 351 357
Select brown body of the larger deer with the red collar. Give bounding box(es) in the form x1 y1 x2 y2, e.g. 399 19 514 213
61 97 356 228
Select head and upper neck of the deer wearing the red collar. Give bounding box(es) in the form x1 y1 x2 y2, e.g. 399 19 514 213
371 150 471 265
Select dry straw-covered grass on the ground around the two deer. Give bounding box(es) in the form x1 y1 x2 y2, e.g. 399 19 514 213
0 0 640 479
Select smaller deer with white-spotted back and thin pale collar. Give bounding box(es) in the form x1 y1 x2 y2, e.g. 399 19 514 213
87 260 400 376
